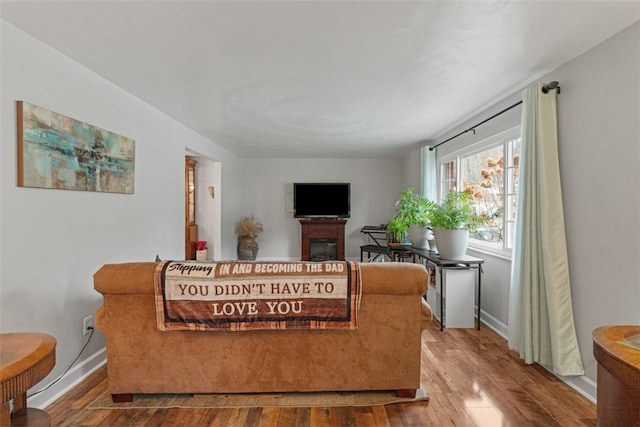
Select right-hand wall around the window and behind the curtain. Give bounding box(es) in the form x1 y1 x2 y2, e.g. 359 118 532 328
428 23 640 398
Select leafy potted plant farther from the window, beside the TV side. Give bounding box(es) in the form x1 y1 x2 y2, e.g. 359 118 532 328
394 187 434 249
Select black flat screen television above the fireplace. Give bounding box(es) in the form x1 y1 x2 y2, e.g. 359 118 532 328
293 182 351 218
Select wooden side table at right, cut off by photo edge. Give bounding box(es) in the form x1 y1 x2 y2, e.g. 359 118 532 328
593 326 640 427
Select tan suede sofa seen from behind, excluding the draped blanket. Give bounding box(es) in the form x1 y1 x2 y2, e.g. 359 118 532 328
94 262 431 401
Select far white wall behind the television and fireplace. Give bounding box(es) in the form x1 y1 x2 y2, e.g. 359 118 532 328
236 159 404 260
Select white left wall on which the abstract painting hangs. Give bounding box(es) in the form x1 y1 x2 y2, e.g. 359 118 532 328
0 21 242 406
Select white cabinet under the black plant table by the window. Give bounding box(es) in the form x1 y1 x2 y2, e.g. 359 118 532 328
427 262 477 328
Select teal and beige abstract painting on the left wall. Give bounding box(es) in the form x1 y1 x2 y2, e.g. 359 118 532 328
17 101 135 194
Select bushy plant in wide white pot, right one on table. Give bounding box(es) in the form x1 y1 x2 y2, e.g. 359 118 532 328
429 190 479 259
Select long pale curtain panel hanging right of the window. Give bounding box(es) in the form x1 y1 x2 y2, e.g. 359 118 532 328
508 84 584 375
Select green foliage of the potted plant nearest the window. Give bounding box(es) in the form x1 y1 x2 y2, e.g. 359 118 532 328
429 191 480 231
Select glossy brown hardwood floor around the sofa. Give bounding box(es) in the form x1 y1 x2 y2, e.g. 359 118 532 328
46 322 596 427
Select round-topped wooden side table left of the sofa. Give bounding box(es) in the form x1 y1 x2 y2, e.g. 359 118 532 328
0 333 56 426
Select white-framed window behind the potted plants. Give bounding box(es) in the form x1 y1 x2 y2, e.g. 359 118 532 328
438 127 520 251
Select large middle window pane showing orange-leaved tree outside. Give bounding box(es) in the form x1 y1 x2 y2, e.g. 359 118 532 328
461 144 504 244
